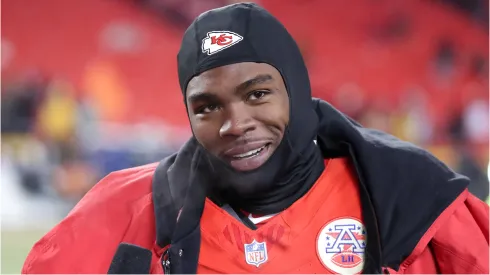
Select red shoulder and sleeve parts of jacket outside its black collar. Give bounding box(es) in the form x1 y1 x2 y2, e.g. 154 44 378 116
22 164 490 274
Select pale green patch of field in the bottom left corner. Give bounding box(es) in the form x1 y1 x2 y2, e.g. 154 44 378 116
0 229 48 274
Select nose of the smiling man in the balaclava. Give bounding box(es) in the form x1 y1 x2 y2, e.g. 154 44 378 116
219 106 256 137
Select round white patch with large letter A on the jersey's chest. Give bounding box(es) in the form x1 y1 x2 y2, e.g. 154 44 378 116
317 217 366 274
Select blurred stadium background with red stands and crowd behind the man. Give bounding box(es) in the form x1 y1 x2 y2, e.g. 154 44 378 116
1 0 489 273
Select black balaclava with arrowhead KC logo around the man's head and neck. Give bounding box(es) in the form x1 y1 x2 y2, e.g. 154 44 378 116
178 3 324 214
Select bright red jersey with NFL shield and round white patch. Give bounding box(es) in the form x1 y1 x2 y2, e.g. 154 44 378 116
198 159 365 274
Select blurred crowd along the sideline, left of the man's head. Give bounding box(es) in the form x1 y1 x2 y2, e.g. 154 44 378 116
1 71 176 206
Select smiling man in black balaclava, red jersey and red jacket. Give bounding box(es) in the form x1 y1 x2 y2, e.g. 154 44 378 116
23 4 489 274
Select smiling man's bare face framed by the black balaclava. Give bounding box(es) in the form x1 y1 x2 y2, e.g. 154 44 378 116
186 62 289 171
